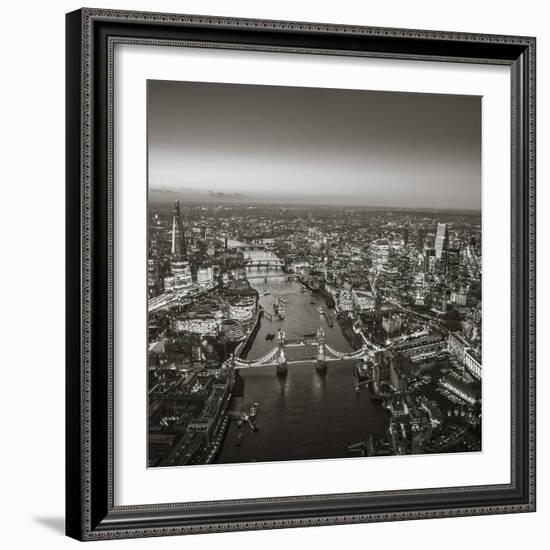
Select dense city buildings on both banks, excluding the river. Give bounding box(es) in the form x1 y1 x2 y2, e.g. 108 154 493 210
148 203 482 466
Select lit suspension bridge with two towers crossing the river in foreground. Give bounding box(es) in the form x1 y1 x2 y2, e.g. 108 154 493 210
233 328 373 374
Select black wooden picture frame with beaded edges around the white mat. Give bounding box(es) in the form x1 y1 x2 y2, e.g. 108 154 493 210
66 9 535 540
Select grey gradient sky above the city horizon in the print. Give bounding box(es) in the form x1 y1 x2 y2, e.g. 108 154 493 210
148 81 481 209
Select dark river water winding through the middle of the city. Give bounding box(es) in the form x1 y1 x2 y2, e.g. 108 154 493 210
215 252 387 463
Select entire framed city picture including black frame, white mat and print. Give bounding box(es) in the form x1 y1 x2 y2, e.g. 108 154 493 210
66 9 535 540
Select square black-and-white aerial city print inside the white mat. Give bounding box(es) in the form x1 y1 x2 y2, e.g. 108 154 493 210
146 81 482 467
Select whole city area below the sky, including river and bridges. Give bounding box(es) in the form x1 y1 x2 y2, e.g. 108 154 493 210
147 199 482 468
